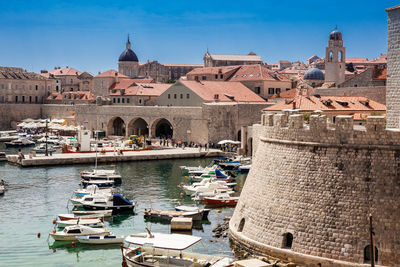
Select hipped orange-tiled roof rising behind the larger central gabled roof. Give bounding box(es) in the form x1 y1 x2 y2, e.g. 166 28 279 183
229 64 290 82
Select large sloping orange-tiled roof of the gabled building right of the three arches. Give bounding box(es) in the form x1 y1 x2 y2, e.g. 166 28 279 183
179 81 266 102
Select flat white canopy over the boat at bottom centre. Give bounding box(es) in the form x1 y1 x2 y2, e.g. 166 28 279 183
125 233 201 250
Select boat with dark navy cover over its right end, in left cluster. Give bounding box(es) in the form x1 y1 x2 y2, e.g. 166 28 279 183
82 193 135 214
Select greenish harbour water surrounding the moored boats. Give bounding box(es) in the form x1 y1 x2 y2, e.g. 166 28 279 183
0 159 244 266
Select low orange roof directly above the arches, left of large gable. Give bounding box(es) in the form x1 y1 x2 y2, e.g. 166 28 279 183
110 83 172 96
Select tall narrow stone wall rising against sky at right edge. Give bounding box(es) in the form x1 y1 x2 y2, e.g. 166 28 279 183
386 7 400 128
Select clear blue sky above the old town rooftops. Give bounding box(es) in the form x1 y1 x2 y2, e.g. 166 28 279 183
0 0 398 74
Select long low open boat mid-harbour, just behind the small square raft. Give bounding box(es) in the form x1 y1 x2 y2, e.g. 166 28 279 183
144 208 204 222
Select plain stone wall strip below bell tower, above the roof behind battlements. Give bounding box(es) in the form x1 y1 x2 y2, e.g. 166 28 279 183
313 86 386 104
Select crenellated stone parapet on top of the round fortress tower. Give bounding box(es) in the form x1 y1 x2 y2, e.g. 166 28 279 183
261 111 400 147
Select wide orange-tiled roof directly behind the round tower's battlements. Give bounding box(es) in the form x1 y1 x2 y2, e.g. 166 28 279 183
264 95 386 112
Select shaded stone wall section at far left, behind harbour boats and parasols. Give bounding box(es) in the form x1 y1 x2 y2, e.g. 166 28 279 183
0 104 42 130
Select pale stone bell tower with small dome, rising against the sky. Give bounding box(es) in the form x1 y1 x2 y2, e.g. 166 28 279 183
325 29 346 85
